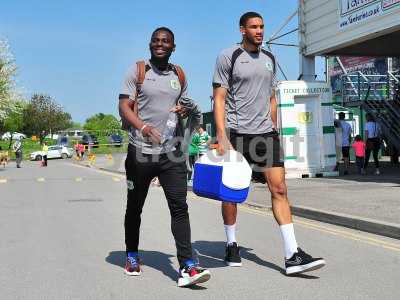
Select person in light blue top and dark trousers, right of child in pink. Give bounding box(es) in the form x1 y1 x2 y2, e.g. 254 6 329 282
364 114 381 175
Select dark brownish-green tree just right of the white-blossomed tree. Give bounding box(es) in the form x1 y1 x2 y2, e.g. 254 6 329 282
23 94 72 144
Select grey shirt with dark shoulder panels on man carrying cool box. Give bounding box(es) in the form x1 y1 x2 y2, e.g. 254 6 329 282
213 45 276 134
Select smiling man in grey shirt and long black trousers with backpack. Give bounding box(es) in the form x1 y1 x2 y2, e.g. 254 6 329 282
119 27 210 287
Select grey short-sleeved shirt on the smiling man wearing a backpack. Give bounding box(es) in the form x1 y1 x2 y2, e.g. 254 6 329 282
120 60 187 154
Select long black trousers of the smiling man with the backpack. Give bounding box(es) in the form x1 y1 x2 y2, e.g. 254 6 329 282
125 145 192 267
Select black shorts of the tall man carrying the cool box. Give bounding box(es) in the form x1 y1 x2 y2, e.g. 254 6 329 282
229 129 285 172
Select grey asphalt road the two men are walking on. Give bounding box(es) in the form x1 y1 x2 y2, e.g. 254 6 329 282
0 160 400 299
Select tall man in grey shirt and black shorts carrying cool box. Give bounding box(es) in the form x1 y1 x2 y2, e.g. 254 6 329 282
213 12 325 274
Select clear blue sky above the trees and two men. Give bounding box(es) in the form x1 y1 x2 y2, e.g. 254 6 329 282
0 0 324 123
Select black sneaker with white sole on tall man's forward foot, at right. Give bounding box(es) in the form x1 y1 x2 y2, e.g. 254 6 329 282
285 248 326 275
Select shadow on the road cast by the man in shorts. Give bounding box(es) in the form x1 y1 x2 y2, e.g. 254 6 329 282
193 241 319 279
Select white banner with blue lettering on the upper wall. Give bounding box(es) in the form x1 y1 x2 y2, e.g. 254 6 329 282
338 0 400 29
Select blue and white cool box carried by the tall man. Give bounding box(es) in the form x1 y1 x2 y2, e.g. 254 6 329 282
193 150 252 203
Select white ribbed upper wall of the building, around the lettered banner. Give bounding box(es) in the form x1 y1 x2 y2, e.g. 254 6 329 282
299 0 400 56
